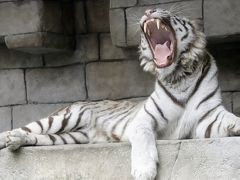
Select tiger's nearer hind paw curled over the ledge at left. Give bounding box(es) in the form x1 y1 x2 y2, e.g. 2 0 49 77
6 130 27 151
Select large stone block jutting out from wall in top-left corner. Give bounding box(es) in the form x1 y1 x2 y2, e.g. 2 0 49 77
0 0 74 54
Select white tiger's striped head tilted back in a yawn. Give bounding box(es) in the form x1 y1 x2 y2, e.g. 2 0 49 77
139 9 206 80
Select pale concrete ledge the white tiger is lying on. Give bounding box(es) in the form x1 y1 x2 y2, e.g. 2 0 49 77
0 137 240 180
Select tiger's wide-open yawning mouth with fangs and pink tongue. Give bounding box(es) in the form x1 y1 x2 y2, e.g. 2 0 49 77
142 18 176 68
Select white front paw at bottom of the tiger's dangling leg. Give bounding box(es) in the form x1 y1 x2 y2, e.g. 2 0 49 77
131 161 157 180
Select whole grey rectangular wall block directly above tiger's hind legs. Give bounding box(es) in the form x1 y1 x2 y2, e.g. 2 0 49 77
26 65 86 103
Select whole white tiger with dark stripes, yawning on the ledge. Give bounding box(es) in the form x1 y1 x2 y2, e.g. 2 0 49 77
0 9 240 180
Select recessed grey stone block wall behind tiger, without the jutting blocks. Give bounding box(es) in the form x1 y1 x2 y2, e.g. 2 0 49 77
0 0 240 131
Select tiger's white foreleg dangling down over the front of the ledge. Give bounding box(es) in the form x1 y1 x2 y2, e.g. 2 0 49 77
127 107 164 180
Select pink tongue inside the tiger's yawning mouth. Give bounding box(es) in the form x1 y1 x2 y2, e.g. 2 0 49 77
154 41 171 67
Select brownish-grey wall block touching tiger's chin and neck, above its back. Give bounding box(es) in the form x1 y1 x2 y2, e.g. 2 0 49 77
86 60 154 100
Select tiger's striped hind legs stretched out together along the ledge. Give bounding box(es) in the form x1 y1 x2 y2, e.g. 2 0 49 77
0 105 92 150
